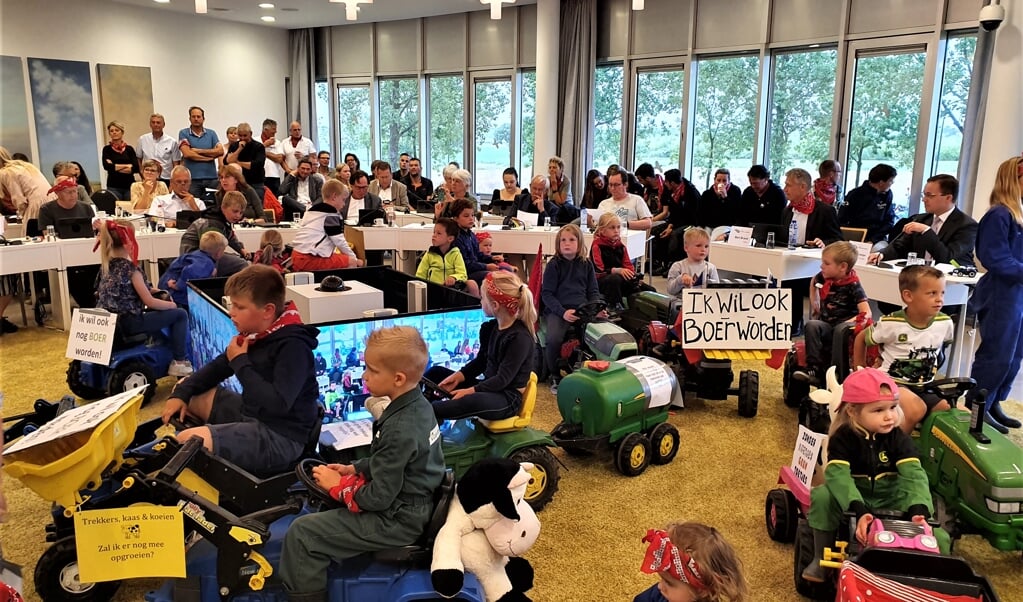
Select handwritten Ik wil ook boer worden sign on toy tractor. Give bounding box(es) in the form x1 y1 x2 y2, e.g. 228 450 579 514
678 289 792 349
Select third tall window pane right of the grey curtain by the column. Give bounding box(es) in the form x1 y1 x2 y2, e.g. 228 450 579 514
693 56 760 189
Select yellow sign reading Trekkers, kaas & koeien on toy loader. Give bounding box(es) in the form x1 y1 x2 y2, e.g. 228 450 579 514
75 506 185 583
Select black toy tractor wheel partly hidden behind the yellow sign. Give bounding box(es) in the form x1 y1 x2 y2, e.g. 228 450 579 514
35 535 121 602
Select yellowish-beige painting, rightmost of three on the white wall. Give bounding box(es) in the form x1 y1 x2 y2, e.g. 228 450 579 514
97 63 153 153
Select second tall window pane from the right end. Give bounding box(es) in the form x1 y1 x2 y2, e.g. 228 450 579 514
845 49 926 217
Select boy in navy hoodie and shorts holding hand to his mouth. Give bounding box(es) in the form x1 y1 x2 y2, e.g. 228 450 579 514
163 265 319 475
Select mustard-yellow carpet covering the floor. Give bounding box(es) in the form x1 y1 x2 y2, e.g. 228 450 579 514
0 315 1023 601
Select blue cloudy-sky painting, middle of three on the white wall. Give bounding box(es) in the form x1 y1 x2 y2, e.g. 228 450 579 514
29 58 102 182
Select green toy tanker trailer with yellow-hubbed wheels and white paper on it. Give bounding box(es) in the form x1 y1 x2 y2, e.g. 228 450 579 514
550 356 681 476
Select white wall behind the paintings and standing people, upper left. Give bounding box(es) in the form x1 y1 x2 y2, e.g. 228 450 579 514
0 0 290 181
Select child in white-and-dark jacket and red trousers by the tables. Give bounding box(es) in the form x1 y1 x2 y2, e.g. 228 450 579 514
292 172 366 271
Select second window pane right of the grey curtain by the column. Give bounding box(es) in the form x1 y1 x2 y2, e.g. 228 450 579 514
633 69 685 173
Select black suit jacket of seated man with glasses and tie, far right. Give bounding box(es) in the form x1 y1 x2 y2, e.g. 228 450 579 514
881 209 977 265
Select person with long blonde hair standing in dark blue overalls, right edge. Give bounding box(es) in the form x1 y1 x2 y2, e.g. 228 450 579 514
970 157 1023 433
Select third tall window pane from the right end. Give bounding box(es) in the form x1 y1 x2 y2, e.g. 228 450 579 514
768 49 838 179
